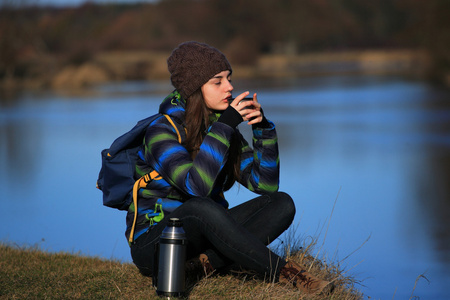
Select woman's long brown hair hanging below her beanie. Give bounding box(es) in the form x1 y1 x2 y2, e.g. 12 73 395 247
183 88 241 191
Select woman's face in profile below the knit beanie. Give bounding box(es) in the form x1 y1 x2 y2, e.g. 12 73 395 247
201 71 233 110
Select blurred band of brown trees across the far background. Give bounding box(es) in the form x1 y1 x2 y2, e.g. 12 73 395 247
0 0 450 84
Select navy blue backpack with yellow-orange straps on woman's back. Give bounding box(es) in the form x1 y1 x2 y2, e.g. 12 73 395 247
97 114 181 238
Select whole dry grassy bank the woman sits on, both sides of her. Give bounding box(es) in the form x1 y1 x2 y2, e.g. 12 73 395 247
0 245 363 300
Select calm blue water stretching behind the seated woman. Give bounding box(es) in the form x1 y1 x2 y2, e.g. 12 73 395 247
0 77 450 299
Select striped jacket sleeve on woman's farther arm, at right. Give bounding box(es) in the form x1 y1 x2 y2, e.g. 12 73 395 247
240 122 280 194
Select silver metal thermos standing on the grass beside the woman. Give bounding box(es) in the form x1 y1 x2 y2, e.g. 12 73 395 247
156 218 187 297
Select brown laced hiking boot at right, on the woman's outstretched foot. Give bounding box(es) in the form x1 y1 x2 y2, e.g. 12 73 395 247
279 261 334 294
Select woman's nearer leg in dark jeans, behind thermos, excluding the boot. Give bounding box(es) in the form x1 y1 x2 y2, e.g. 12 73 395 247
131 198 286 278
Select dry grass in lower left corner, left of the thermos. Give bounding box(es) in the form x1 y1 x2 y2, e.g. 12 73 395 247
0 245 152 299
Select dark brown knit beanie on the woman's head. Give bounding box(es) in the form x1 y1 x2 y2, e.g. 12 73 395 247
167 42 232 99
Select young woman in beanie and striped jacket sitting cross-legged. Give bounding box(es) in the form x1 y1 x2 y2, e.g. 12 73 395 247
126 42 328 292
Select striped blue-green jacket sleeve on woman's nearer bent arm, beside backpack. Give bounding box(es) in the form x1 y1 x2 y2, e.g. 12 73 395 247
144 121 234 197
